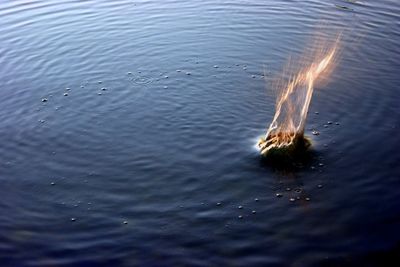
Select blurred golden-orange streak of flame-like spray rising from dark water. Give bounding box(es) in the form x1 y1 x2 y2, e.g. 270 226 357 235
258 36 340 154
